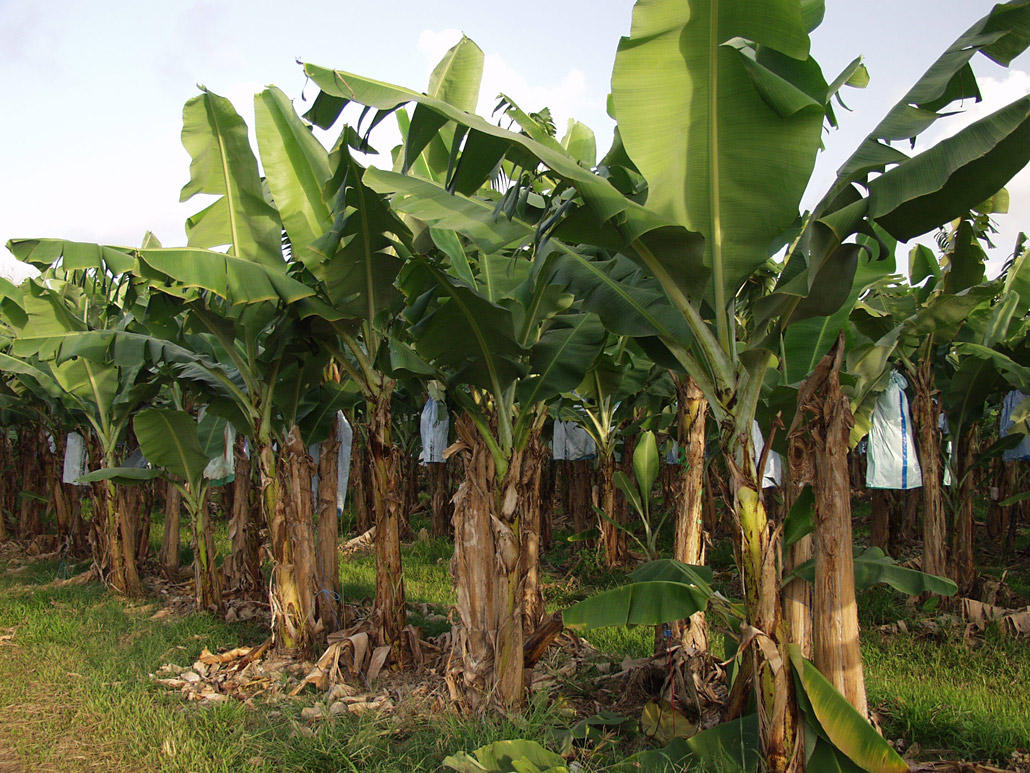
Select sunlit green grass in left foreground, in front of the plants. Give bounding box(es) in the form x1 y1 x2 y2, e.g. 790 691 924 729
0 545 585 773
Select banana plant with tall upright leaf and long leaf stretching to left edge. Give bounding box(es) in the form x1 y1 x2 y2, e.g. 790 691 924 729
8 91 329 649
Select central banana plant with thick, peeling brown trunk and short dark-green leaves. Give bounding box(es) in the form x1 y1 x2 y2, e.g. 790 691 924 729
394 245 606 706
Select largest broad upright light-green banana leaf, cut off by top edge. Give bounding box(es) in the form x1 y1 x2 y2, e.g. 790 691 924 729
612 0 828 314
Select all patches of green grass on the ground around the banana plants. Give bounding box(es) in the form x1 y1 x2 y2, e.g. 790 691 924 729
0 509 1030 773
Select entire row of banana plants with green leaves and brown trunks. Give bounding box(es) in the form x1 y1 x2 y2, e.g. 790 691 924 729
0 0 1030 771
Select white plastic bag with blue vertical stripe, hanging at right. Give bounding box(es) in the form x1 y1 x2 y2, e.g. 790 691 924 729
865 371 923 489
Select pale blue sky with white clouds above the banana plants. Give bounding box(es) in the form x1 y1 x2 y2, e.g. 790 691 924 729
0 0 1030 278
